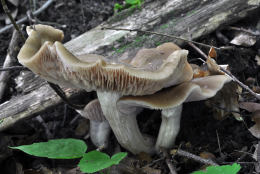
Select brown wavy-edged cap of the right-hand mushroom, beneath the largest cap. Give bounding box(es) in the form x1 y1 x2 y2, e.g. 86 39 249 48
117 75 231 112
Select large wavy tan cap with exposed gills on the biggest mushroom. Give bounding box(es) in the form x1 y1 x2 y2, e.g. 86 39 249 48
18 25 192 95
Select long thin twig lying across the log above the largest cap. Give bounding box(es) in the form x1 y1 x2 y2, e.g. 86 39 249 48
101 27 220 50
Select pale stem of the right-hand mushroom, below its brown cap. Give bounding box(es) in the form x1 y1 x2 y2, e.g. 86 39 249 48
155 104 182 152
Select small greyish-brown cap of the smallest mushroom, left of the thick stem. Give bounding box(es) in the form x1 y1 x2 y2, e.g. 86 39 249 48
77 99 106 122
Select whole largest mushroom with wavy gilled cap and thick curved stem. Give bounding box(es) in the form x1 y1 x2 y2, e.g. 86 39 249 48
18 25 193 154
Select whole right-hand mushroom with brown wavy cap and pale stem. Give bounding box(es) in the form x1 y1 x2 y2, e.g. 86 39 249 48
117 75 231 151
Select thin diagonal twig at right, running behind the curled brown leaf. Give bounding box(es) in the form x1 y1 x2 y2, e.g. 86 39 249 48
189 43 260 100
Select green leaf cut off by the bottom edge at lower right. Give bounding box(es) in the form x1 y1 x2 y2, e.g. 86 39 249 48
192 163 241 174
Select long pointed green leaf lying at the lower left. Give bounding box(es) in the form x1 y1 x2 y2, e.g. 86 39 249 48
11 138 87 159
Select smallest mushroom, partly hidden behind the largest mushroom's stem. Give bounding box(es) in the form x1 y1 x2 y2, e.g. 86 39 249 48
77 99 111 148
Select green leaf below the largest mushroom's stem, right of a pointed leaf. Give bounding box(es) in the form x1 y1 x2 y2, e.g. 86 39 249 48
78 150 127 173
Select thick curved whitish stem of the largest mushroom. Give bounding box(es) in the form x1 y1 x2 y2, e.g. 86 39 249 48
97 91 155 154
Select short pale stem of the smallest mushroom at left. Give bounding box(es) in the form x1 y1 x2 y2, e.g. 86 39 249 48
90 120 111 148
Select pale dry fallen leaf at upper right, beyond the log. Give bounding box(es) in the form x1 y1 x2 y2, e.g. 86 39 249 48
230 32 256 47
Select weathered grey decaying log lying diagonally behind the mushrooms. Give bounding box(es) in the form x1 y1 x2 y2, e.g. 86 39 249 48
0 0 260 130
